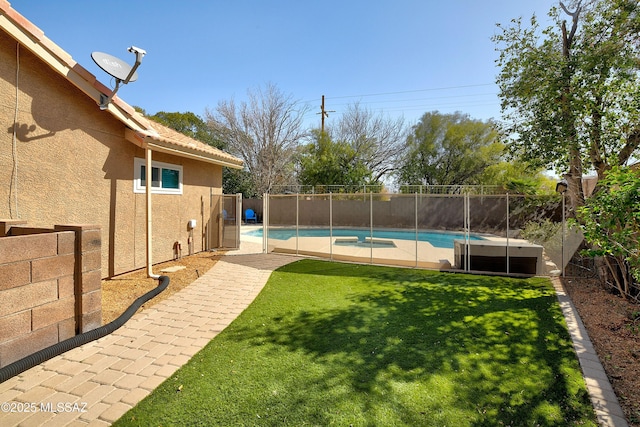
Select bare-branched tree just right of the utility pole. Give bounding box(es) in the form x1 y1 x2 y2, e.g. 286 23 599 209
328 103 407 183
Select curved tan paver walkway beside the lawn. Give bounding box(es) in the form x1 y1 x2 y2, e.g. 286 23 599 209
0 242 297 427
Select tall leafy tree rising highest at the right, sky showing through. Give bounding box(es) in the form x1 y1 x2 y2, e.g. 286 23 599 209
493 0 640 210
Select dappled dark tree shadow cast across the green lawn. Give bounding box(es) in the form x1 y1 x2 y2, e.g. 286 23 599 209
233 260 590 426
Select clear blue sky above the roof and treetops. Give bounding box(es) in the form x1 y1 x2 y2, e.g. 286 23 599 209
11 0 557 127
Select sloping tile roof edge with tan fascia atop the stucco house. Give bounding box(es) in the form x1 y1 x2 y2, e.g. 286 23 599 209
0 0 243 169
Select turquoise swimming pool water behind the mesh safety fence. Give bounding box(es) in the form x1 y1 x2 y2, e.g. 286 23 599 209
246 228 485 249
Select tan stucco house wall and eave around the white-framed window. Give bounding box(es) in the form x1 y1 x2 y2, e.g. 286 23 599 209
0 5 242 277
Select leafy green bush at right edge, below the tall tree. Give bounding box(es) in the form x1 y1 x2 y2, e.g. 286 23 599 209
578 167 640 299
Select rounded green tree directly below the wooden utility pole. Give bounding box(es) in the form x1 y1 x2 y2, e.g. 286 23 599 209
298 130 374 192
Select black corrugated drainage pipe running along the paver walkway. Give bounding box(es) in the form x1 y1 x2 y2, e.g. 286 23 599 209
0 276 169 384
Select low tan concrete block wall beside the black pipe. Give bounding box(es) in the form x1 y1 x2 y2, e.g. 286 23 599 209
0 220 102 367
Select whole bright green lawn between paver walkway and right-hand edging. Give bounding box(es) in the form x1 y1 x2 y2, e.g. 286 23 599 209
115 260 597 427
